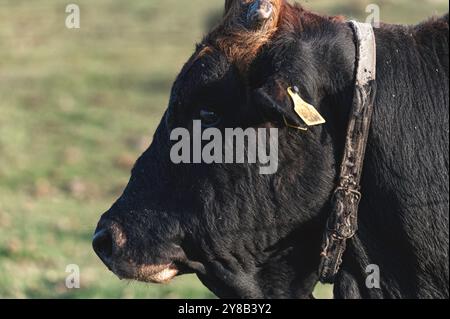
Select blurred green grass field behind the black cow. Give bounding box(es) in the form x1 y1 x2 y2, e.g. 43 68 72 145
0 0 448 298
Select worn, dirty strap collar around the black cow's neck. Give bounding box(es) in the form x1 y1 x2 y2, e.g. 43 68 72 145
319 21 376 283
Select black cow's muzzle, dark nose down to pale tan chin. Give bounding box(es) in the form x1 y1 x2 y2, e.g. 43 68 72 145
92 221 178 283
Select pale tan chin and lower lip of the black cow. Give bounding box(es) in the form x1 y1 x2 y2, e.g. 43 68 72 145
111 263 178 284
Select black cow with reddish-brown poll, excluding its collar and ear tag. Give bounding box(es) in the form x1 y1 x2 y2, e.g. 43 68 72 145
93 0 449 298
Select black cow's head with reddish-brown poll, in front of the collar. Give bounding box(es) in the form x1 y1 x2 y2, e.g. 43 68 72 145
93 0 354 298
